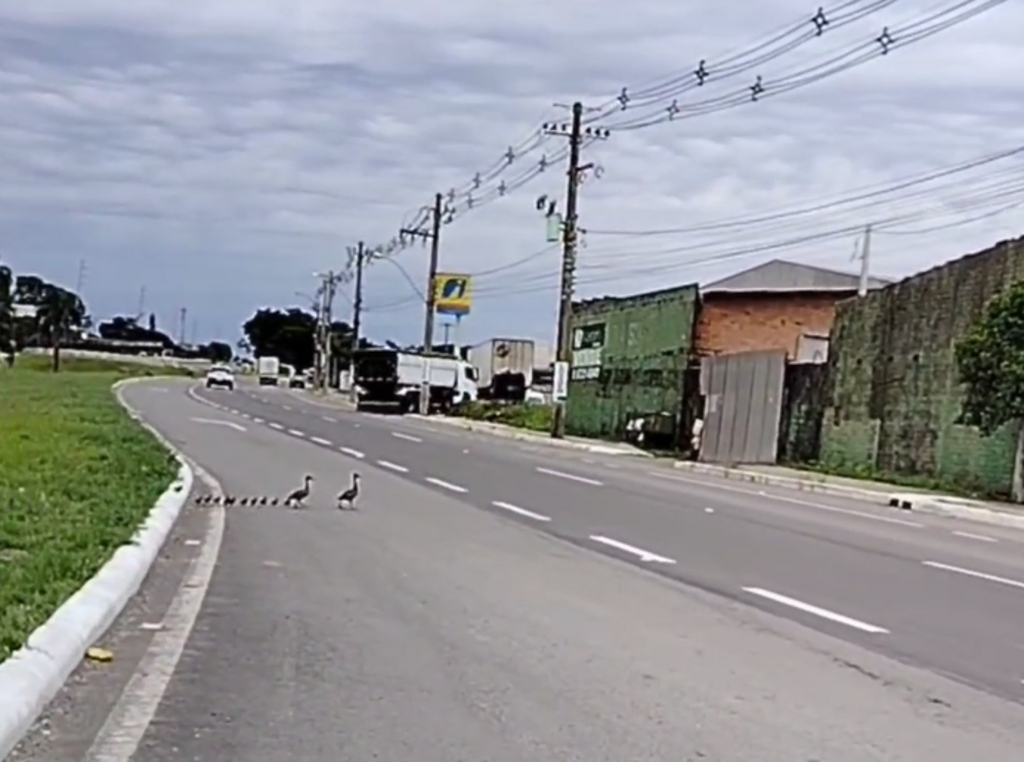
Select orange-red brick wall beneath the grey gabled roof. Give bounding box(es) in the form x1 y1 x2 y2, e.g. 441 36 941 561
695 292 855 357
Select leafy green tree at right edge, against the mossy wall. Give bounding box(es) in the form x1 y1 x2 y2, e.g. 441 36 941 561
955 282 1024 435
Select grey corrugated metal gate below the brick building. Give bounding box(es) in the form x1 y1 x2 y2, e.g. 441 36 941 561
699 349 786 464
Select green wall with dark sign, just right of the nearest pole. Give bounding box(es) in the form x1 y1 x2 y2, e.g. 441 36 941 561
566 284 697 438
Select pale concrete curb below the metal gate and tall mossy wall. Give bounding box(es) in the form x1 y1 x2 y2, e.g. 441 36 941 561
672 461 1024 530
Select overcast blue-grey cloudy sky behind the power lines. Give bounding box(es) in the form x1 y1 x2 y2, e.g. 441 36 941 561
0 0 1024 348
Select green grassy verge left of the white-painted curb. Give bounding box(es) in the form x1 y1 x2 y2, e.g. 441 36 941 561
0 357 178 661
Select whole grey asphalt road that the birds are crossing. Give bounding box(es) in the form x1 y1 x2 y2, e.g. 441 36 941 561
17 381 1024 762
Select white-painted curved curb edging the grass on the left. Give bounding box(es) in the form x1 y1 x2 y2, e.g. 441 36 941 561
0 379 195 759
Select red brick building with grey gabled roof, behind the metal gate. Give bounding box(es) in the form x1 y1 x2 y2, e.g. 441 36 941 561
694 259 888 363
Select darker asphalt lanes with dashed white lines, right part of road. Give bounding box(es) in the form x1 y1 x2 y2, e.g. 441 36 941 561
195 381 1024 702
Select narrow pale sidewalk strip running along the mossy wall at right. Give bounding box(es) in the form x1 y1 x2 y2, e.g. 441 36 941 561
672 461 1024 528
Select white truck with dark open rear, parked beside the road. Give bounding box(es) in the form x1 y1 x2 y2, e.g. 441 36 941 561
352 349 477 413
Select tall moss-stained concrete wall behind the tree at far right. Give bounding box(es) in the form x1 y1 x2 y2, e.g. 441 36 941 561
821 239 1024 496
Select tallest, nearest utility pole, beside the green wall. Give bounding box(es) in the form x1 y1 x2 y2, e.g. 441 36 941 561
544 101 608 439
